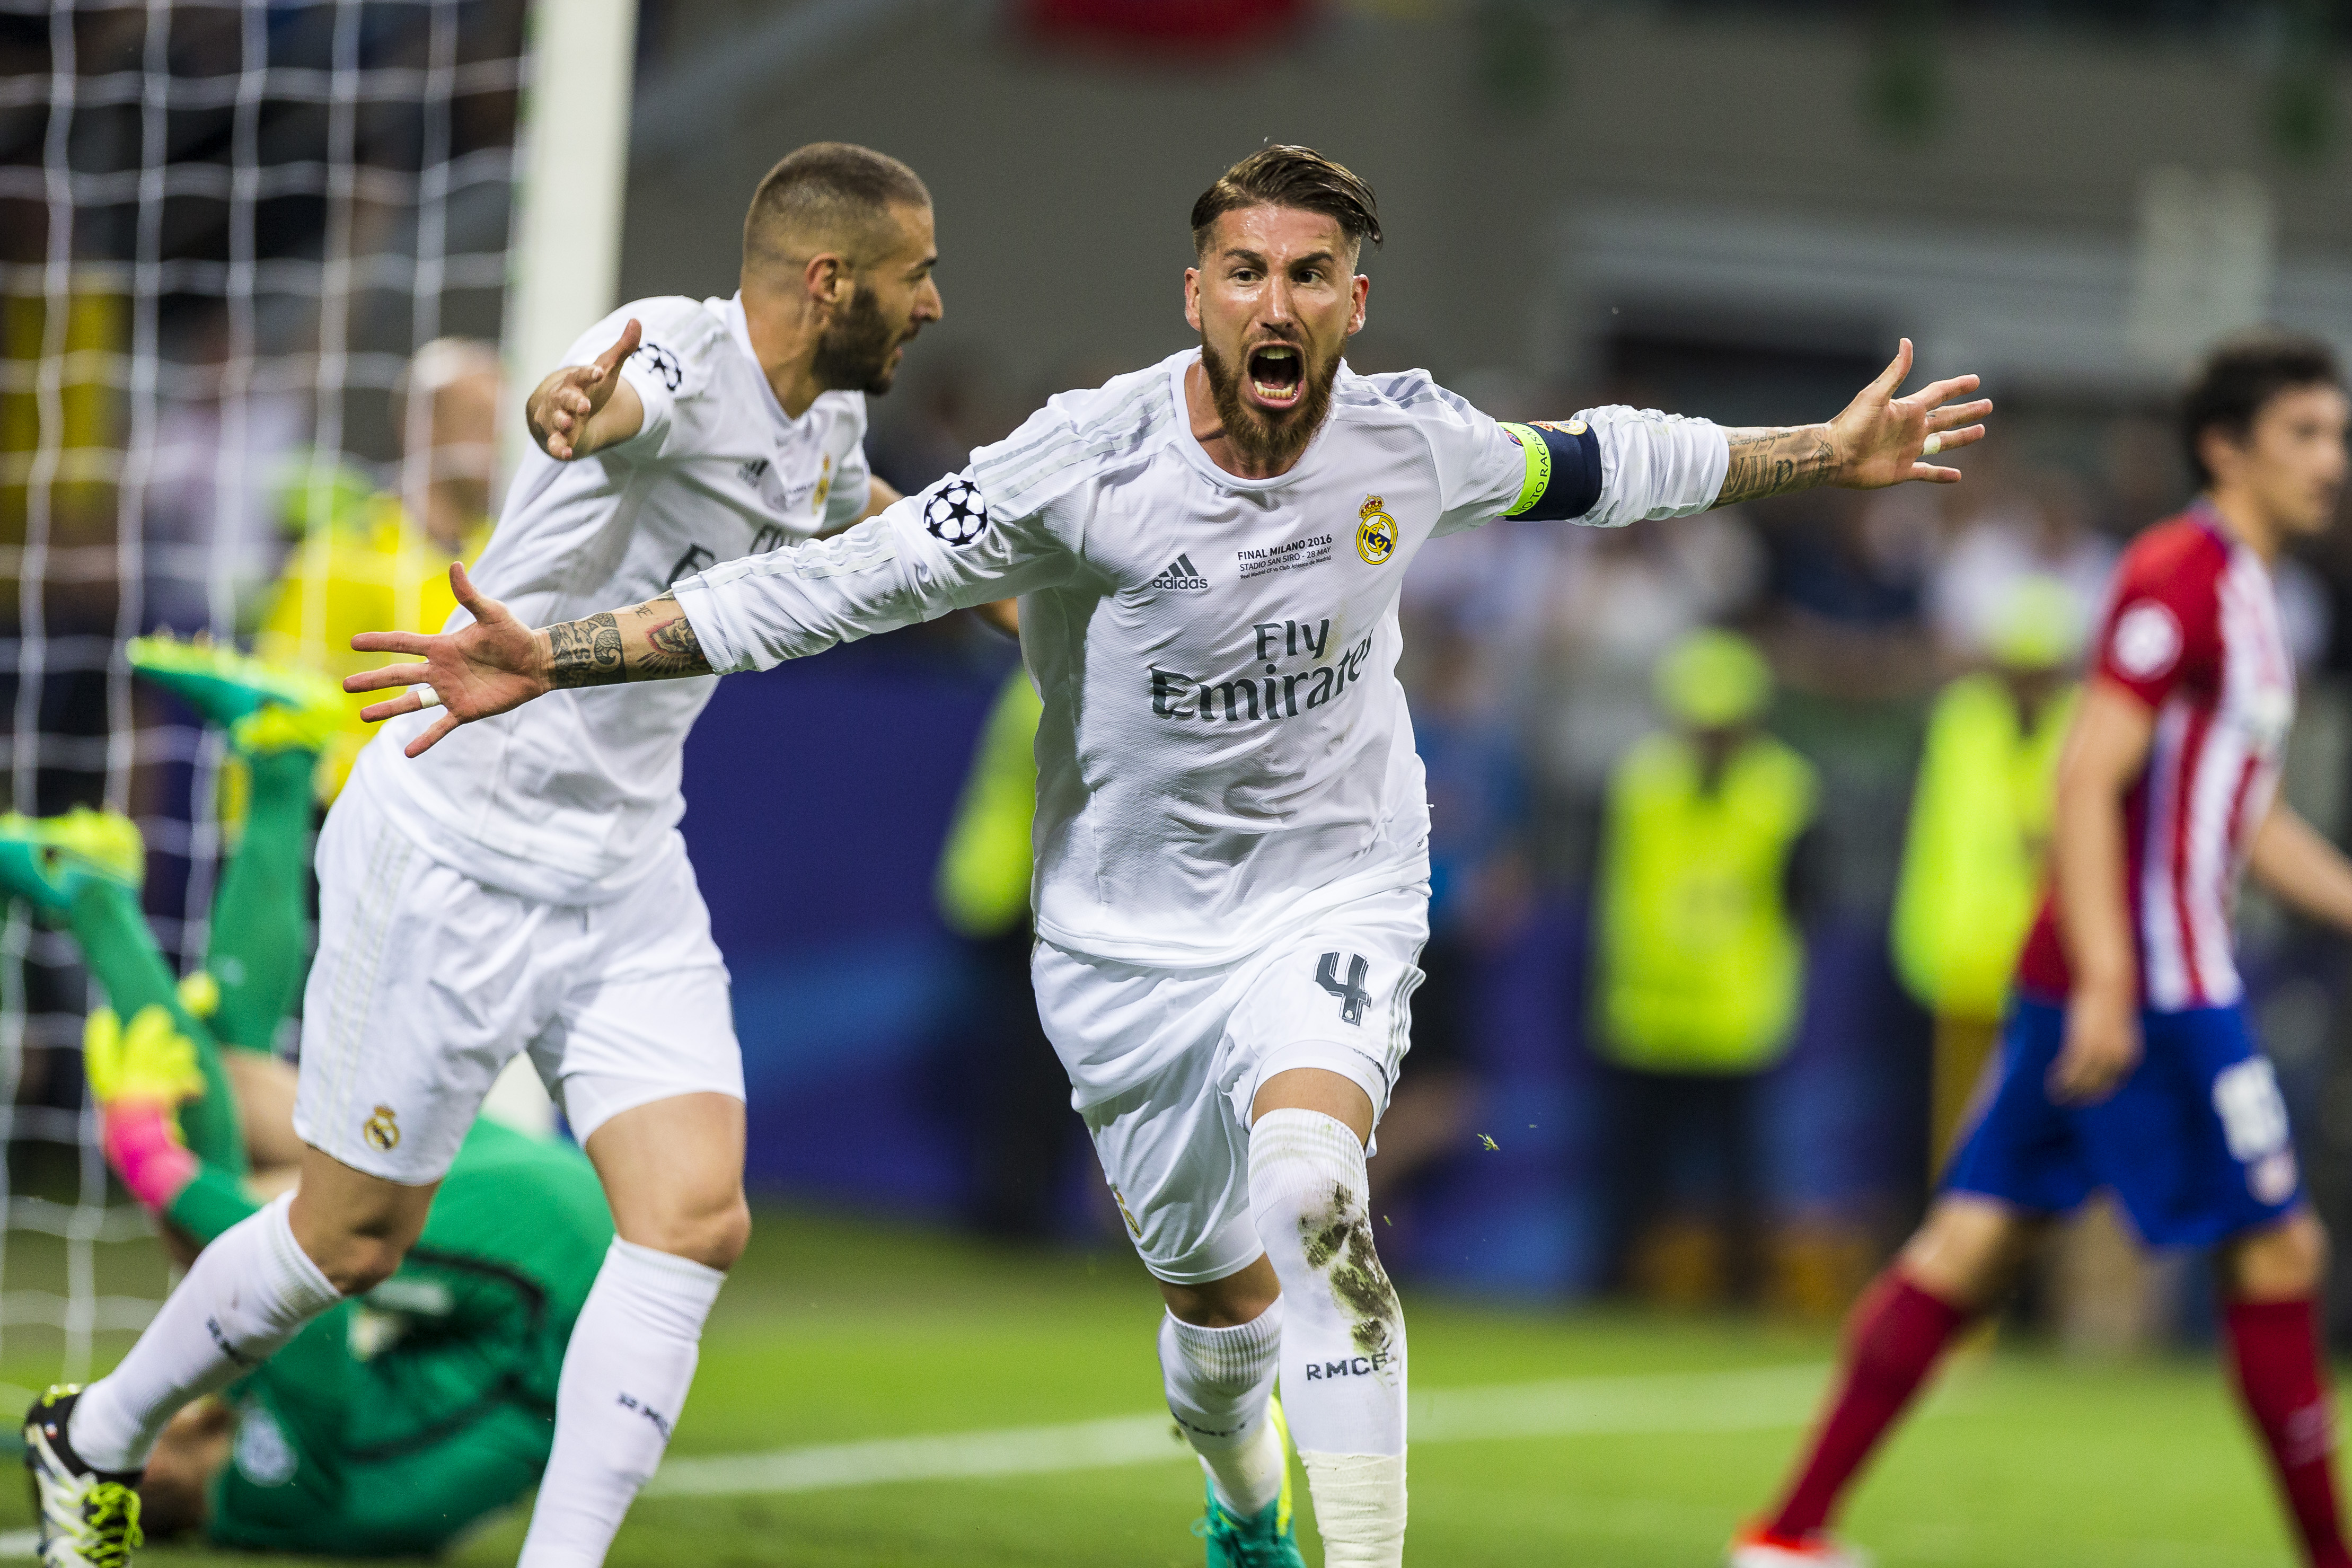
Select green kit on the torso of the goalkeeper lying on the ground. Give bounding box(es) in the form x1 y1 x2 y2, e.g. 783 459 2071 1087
189 1121 612 1556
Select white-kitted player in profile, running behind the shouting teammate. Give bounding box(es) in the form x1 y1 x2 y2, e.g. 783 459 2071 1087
21 144 941 1568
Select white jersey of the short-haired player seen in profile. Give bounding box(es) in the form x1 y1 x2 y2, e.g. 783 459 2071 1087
362 298 870 903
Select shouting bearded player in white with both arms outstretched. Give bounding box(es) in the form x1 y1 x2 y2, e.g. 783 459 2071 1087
350 146 1990 1566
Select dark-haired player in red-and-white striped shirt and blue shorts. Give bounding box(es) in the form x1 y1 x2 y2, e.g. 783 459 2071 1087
1731 336 2352 1568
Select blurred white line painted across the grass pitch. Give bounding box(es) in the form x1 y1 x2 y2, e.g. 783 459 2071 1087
645 1363 1828 1497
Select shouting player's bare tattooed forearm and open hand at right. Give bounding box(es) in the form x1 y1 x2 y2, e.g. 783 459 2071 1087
1715 339 1992 505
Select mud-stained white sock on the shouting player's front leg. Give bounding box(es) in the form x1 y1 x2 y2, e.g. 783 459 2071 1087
1249 1109 1404 1568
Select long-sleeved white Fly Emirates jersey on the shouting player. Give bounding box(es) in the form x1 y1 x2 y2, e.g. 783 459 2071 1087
675 350 1729 968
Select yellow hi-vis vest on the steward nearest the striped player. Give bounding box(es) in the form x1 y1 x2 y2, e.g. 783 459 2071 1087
1893 675 2077 1020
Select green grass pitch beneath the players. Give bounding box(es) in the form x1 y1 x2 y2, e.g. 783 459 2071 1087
0 1211 2293 1568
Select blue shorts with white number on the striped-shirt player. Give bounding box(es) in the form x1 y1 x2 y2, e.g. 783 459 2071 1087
1943 997 2303 1246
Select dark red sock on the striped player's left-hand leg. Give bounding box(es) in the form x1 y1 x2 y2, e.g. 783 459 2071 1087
1771 1270 1974 1540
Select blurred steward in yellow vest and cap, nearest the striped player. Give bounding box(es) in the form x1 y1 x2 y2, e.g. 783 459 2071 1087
1893 578 2082 1168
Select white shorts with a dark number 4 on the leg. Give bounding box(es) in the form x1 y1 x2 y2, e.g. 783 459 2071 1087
1030 884 1430 1286
